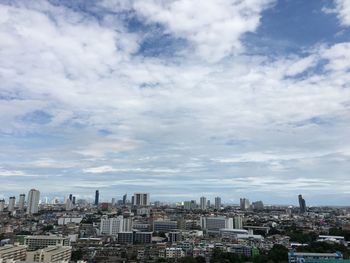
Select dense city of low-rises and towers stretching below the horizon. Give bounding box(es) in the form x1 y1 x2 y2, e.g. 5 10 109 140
0 189 350 263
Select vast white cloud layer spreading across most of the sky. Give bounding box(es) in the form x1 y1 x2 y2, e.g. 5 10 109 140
0 0 350 204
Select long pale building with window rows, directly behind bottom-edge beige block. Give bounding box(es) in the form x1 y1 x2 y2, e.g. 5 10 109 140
24 235 70 251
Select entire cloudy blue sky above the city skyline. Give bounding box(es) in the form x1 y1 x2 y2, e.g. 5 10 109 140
0 0 350 205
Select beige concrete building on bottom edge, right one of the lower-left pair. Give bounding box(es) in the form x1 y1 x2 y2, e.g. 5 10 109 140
27 246 72 263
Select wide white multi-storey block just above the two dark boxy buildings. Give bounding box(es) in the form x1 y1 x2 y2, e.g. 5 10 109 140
100 216 132 236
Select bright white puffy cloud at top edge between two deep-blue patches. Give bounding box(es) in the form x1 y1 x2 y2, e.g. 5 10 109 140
133 0 274 61
